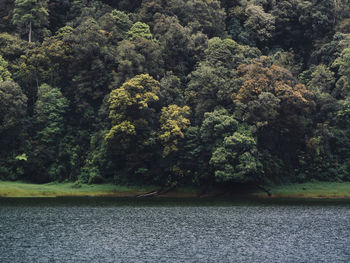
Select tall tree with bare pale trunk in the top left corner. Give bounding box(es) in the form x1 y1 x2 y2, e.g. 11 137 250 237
12 0 49 42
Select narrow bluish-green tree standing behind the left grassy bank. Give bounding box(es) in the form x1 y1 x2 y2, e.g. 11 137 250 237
28 84 68 182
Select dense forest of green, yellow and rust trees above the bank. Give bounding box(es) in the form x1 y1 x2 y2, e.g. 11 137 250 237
0 0 350 186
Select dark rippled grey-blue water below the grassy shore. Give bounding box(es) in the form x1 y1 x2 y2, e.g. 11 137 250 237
0 199 350 263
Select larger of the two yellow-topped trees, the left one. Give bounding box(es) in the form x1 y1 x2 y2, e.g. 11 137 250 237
105 74 160 182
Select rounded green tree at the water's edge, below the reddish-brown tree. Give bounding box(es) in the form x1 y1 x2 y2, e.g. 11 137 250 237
199 107 262 183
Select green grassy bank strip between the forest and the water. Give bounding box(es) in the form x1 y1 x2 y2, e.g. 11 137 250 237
0 181 350 199
